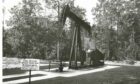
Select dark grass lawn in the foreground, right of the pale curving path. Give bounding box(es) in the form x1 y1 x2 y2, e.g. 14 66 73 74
21 66 140 84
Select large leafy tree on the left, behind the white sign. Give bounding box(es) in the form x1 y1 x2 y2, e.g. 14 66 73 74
4 0 48 58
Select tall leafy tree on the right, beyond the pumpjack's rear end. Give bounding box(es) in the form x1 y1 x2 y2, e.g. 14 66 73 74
93 0 139 60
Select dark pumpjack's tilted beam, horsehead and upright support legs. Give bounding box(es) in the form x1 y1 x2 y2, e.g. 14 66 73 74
60 5 104 69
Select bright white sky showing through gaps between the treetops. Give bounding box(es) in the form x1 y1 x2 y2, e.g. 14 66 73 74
4 0 97 25
